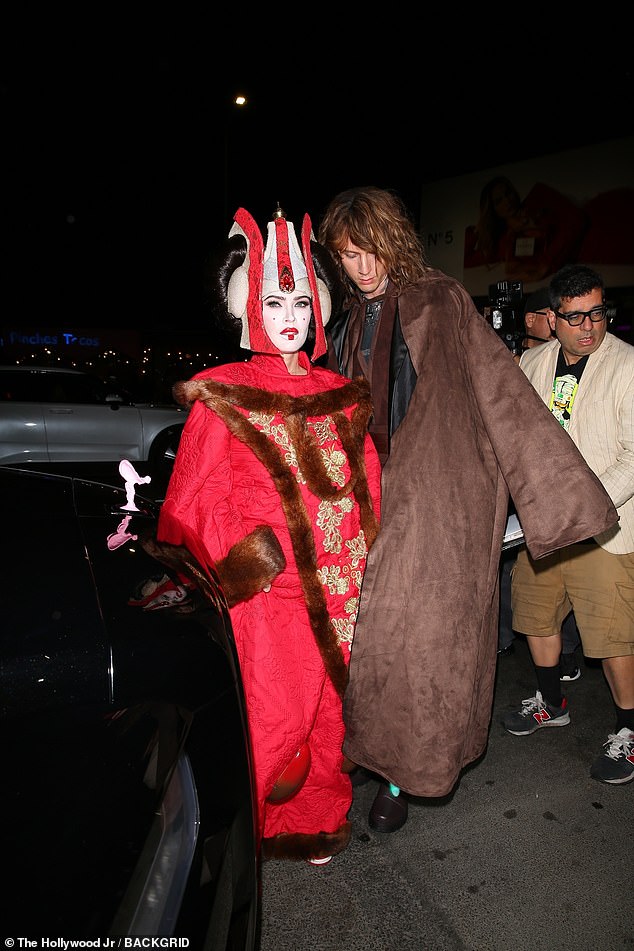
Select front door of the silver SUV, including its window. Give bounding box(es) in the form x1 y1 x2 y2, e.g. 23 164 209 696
42 373 143 462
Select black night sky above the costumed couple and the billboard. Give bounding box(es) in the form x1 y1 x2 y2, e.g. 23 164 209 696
0 21 634 333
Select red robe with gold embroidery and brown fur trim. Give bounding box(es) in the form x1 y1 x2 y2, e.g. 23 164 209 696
158 354 380 858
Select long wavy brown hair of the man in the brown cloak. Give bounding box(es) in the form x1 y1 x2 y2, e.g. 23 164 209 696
319 185 430 294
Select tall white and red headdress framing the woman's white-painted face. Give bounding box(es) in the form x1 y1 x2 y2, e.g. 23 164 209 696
227 208 331 362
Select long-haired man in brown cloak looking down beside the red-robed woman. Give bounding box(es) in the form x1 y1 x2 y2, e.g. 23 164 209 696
319 187 617 832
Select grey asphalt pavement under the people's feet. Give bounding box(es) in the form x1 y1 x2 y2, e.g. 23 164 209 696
254 638 634 951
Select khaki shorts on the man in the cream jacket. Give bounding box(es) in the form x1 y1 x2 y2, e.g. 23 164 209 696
511 543 634 658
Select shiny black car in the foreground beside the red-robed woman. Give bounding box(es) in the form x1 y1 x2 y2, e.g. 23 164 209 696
0 466 258 951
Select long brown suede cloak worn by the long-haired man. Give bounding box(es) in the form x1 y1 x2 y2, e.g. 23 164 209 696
344 271 618 796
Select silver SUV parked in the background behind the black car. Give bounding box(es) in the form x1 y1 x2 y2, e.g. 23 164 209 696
0 366 187 475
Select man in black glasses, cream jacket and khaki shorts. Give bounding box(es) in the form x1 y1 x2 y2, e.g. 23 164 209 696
503 264 634 784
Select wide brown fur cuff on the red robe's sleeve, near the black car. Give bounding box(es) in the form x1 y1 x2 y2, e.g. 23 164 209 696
216 525 286 608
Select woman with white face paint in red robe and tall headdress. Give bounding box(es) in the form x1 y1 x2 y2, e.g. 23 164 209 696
158 209 380 863
